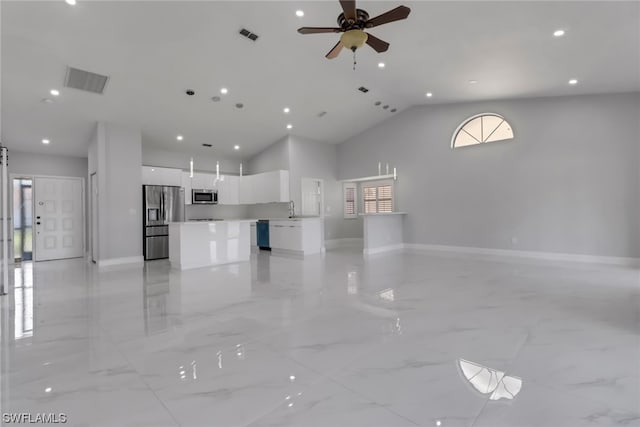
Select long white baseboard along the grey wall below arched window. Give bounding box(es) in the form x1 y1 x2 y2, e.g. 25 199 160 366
404 243 640 267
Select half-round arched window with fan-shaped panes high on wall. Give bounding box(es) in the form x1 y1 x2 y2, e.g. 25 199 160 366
451 113 513 148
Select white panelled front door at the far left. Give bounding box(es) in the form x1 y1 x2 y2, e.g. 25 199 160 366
33 177 84 261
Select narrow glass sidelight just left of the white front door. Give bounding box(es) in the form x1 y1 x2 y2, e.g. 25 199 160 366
13 177 33 262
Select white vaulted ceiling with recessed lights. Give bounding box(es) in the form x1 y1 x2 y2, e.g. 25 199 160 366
1 0 640 157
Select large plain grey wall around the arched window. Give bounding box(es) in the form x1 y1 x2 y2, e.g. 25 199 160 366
337 93 640 257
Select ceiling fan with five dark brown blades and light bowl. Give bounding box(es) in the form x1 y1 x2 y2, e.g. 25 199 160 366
298 0 411 69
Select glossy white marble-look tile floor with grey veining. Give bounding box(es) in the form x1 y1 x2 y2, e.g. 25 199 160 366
0 249 640 427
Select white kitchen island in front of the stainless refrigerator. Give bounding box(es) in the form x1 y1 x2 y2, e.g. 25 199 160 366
169 219 255 270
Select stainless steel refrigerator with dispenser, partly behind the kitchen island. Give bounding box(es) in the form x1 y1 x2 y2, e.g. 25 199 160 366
142 185 184 260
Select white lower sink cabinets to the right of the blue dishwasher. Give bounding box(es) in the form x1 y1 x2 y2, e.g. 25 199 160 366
269 218 323 255
